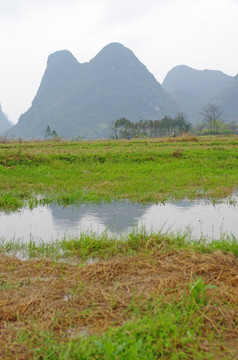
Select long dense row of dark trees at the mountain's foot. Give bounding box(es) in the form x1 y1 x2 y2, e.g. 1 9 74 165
112 114 191 139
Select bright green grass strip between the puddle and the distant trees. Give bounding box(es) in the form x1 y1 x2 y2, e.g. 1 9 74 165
0 135 238 210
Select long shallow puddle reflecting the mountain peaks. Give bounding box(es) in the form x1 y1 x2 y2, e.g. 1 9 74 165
0 196 238 242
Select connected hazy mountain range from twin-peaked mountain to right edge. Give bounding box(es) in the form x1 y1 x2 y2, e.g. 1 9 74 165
0 43 238 139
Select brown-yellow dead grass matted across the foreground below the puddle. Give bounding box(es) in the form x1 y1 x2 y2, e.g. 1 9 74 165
0 249 238 359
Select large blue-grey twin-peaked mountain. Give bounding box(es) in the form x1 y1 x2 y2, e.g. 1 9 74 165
7 43 178 138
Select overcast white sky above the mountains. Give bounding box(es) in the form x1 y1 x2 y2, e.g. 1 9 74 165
0 0 238 123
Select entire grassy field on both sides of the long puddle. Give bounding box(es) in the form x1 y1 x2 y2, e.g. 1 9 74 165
0 136 238 360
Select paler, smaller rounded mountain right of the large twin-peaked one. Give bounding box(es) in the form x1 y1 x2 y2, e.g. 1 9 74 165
162 65 232 123
